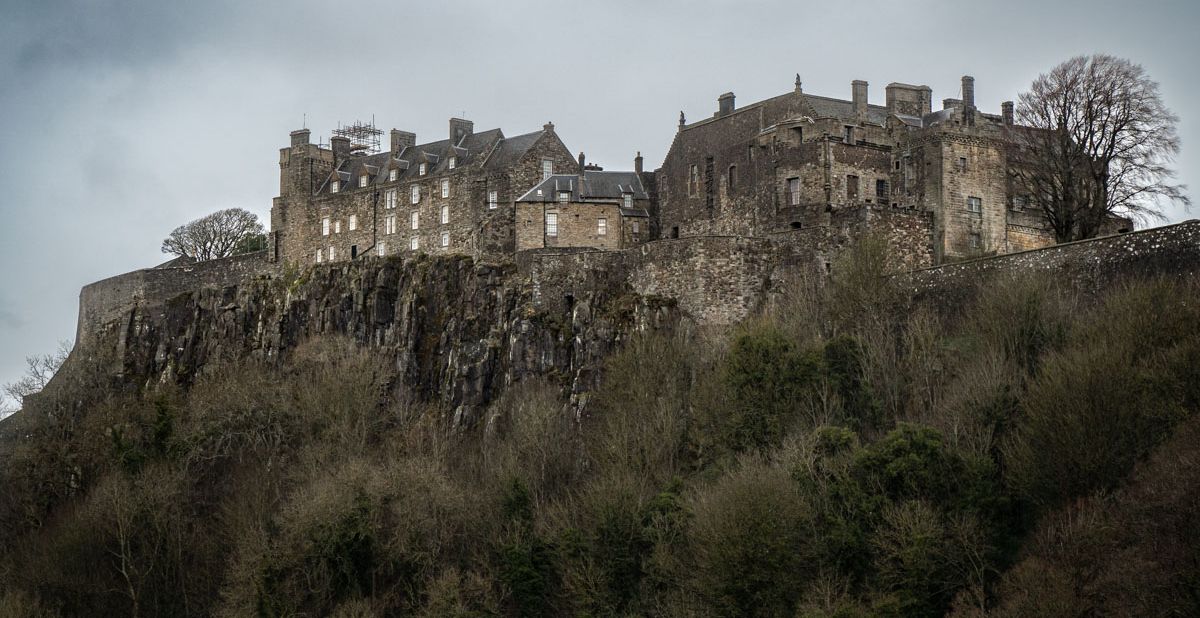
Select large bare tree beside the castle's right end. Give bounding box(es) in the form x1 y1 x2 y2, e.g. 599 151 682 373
1012 54 1192 242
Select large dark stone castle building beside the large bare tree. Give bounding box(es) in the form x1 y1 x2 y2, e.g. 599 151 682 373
658 76 1054 262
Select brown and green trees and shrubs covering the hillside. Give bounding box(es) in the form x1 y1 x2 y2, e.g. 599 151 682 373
0 241 1200 617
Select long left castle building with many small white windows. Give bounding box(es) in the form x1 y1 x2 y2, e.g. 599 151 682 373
270 119 578 264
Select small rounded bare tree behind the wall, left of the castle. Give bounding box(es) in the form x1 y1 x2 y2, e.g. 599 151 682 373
162 208 265 260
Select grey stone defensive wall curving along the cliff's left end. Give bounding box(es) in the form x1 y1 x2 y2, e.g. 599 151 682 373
76 251 277 343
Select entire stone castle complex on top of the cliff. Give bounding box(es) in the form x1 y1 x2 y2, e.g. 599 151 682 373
270 76 1121 266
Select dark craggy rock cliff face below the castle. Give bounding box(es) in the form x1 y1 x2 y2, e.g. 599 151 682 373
77 257 680 425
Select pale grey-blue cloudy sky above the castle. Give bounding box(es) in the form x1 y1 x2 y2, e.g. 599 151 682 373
0 0 1200 405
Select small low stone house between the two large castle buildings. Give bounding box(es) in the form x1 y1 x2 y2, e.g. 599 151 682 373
516 166 650 251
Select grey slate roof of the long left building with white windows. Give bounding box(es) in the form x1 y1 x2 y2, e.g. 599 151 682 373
318 128 542 193
